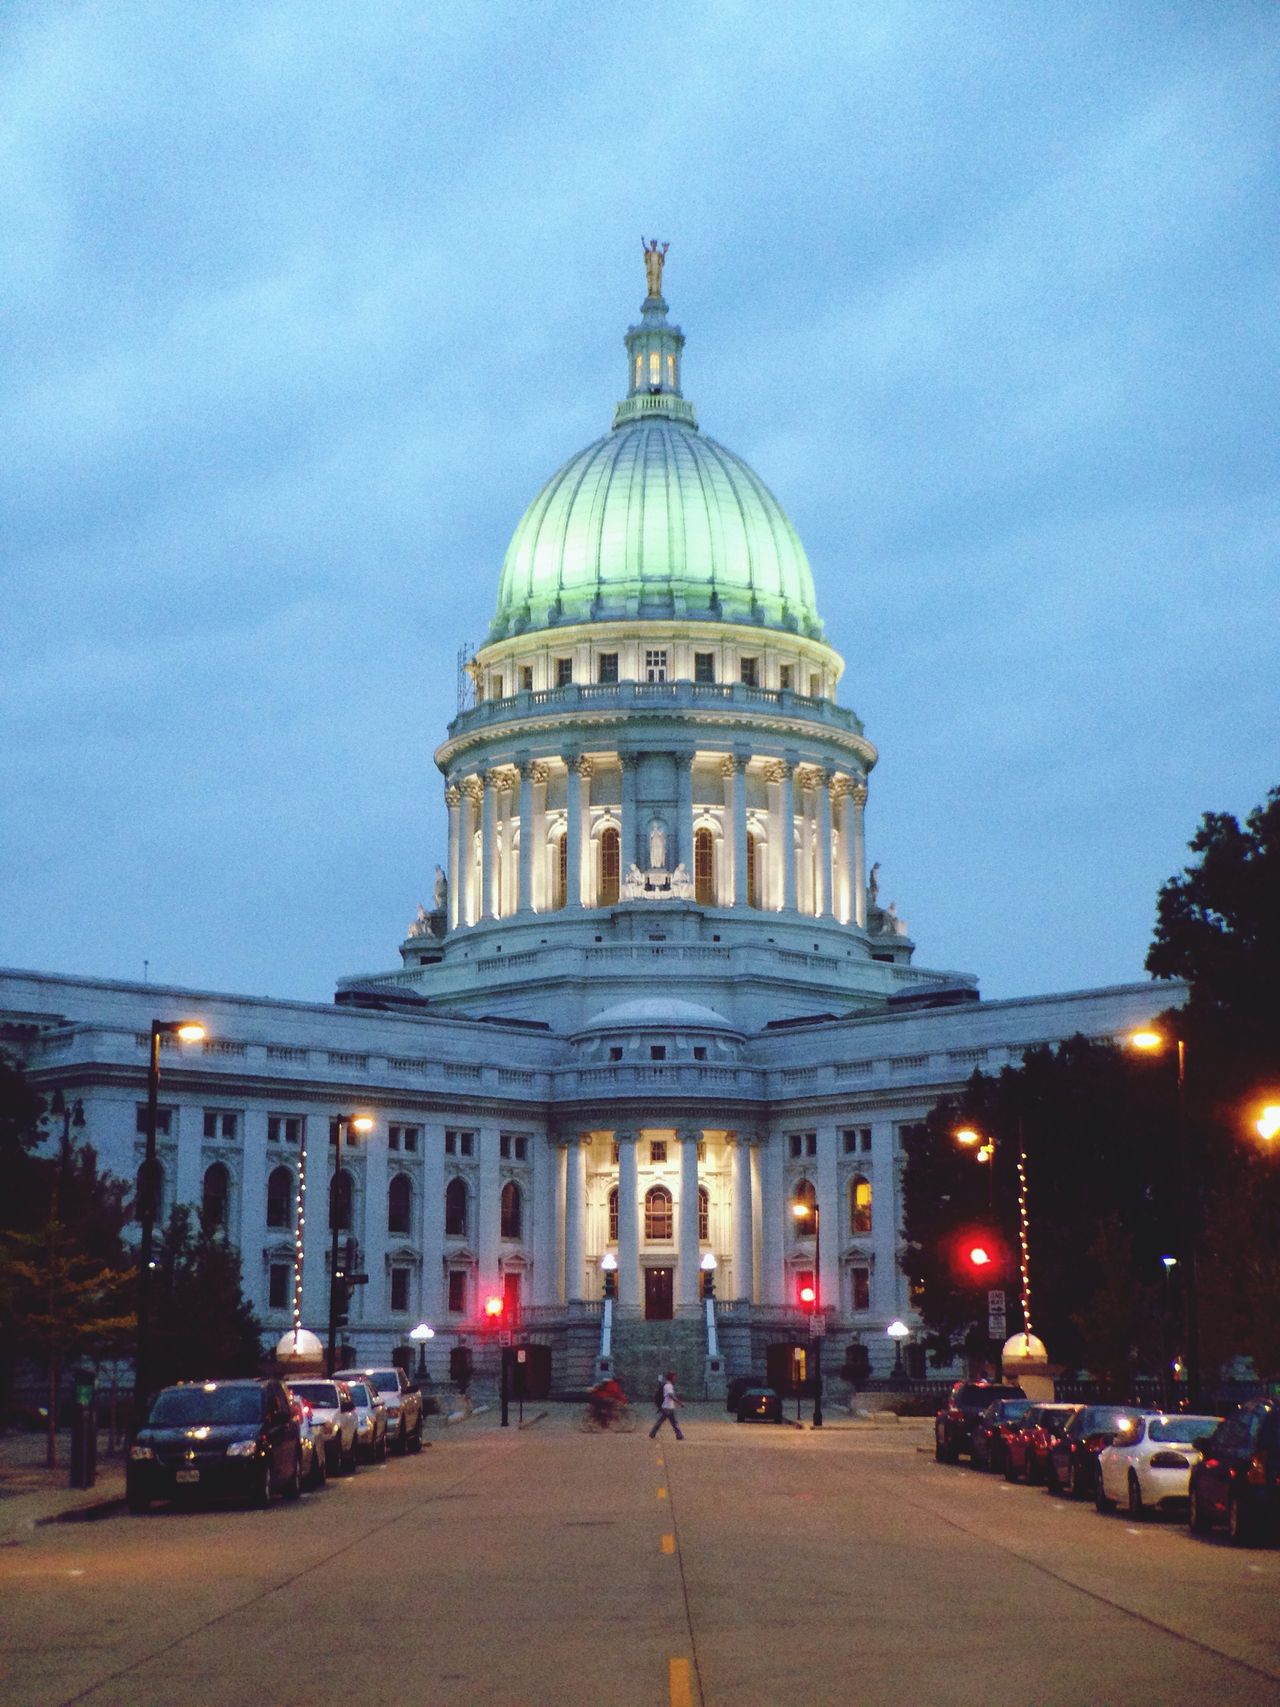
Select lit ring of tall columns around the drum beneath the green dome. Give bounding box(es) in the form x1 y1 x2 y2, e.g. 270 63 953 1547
445 751 867 930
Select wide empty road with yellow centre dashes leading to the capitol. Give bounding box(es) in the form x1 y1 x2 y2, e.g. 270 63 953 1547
0 1408 1280 1707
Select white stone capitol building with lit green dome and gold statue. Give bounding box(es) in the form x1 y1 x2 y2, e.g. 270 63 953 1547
0 246 1169 1395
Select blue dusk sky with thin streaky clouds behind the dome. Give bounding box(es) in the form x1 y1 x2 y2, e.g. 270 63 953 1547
0 0 1280 1000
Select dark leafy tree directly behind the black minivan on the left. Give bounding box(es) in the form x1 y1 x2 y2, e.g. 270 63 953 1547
152 1203 263 1388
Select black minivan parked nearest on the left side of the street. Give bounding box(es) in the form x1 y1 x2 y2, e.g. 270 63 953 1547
125 1381 302 1514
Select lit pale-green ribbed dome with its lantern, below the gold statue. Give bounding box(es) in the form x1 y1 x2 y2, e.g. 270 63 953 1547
490 276 823 640
